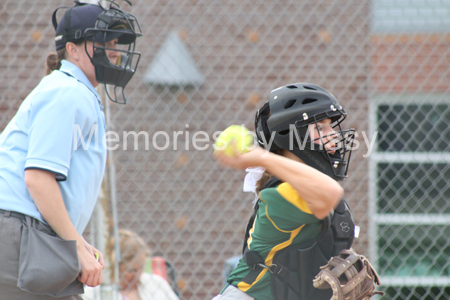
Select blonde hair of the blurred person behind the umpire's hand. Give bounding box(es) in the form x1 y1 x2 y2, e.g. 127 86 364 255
106 229 151 281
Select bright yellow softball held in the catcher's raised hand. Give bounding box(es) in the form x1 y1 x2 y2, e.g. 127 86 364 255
214 125 253 157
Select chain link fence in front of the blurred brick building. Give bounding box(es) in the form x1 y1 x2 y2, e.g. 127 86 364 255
0 0 450 300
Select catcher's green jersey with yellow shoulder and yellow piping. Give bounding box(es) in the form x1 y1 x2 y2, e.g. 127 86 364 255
228 182 321 300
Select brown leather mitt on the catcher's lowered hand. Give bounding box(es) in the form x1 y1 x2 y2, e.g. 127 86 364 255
313 249 384 300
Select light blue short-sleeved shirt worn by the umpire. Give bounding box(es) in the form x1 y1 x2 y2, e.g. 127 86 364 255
0 60 106 234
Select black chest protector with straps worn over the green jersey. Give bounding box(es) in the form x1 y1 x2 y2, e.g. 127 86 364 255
242 178 355 300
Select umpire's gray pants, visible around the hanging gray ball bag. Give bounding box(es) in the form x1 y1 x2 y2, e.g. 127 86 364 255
0 214 82 300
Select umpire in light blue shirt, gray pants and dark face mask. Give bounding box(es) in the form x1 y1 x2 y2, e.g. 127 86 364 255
0 1 141 300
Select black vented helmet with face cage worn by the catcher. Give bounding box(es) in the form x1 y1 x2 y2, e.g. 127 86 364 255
255 83 355 180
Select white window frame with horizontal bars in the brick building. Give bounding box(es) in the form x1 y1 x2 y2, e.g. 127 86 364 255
368 94 450 287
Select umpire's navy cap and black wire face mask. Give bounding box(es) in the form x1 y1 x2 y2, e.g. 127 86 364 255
52 0 142 104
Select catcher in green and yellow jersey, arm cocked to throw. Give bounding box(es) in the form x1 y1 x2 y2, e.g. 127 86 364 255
214 83 379 300
